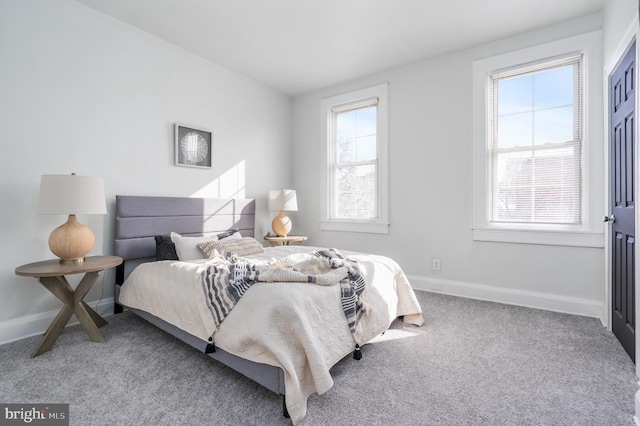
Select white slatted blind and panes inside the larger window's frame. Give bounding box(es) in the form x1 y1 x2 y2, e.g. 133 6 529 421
489 56 582 224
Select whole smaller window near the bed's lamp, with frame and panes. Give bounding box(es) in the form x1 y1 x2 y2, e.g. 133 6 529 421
321 84 388 233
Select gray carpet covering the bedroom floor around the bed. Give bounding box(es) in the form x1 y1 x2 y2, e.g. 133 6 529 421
0 292 637 426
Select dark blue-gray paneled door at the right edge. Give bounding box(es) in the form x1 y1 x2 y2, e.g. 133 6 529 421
605 43 636 362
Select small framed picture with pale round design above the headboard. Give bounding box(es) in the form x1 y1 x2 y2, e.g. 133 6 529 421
175 124 213 169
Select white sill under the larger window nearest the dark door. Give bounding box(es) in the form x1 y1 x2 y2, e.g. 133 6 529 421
472 228 604 248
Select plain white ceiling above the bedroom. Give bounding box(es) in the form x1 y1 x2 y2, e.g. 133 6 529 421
76 0 605 95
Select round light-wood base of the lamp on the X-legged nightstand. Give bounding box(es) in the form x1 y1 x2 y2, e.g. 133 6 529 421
49 214 95 264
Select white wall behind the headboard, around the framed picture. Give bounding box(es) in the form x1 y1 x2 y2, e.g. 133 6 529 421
0 0 291 342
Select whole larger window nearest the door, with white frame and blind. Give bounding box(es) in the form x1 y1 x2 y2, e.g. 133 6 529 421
473 32 604 247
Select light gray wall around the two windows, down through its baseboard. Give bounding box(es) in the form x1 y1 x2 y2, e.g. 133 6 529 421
292 15 605 317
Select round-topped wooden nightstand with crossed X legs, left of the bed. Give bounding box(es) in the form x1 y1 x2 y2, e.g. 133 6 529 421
16 256 122 358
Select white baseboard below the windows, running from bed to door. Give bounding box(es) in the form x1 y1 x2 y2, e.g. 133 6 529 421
407 276 606 326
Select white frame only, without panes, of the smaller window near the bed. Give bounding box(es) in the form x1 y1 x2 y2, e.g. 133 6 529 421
320 83 389 234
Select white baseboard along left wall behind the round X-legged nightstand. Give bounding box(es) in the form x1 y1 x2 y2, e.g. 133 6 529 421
0 297 113 345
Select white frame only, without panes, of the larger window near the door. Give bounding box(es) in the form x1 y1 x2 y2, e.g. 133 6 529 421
472 31 604 247
